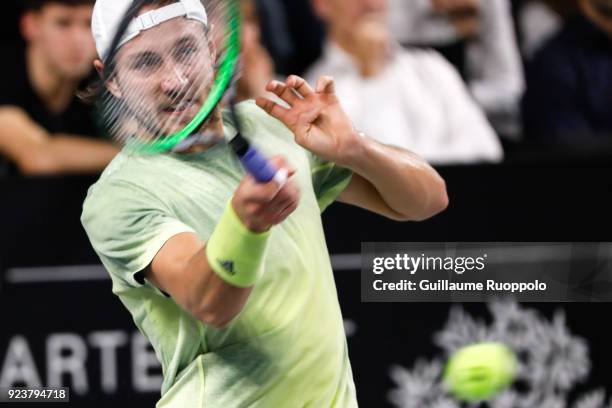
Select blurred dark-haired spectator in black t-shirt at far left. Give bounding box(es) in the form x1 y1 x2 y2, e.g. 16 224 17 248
0 0 116 174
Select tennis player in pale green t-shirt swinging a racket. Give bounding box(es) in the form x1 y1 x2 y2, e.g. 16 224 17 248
82 0 447 408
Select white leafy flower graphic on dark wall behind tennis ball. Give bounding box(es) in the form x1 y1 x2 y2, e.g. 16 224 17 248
389 299 612 408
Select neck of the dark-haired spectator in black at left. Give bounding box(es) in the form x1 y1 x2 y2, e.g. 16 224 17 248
26 47 79 113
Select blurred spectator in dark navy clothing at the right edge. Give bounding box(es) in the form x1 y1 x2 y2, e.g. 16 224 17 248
523 0 612 143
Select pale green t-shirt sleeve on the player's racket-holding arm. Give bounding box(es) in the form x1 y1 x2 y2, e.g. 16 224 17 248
81 183 195 287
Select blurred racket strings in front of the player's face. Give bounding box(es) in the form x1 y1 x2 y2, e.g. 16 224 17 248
100 0 235 148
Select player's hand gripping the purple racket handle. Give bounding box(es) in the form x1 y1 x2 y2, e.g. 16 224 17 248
232 156 300 233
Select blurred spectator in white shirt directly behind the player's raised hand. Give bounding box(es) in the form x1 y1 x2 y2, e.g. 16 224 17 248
307 0 503 164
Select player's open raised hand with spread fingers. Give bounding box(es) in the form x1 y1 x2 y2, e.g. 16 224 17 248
257 75 361 165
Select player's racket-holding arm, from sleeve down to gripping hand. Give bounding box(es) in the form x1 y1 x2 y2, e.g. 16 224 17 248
144 157 300 329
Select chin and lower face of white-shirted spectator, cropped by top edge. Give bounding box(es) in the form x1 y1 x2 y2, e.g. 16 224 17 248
315 0 387 32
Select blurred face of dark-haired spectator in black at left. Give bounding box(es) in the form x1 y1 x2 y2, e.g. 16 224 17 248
27 3 96 79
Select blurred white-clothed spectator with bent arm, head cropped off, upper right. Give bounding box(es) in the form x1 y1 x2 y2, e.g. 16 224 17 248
389 0 525 136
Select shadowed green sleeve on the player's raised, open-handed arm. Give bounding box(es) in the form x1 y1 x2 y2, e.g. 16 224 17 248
308 153 353 212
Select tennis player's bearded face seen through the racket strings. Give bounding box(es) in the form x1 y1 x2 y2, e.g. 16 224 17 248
109 18 215 136
